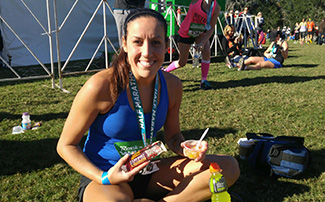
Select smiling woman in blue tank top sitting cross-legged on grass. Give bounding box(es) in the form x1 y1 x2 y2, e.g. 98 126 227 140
57 8 240 202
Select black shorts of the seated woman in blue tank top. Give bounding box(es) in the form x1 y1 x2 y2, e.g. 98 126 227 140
78 174 151 202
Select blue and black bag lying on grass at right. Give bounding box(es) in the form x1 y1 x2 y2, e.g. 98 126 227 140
246 133 311 178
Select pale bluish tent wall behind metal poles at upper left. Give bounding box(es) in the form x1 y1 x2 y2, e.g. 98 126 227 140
0 0 118 67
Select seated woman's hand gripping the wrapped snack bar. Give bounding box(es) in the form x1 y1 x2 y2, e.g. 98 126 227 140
107 154 149 184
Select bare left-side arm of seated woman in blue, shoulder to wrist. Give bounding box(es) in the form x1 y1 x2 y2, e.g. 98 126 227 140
57 72 110 183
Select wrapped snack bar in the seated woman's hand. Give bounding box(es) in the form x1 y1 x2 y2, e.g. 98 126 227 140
122 141 167 172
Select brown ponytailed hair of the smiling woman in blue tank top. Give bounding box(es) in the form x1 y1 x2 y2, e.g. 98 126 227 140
110 8 168 101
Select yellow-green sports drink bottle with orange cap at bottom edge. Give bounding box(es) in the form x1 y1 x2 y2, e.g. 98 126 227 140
209 163 231 202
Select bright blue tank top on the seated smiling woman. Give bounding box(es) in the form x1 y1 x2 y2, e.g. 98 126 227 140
83 70 169 170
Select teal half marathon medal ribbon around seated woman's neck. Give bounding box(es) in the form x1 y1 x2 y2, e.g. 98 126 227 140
129 71 159 147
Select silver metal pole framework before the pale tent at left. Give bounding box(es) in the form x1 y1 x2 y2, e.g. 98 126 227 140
0 0 117 90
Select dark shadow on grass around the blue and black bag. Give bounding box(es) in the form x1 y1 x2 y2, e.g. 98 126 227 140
229 149 325 202
